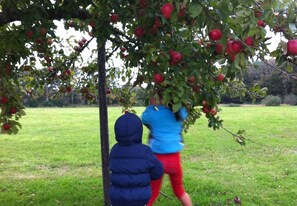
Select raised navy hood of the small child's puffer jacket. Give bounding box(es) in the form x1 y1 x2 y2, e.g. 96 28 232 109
114 113 143 145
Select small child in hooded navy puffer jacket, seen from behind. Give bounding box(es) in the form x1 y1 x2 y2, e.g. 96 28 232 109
109 113 163 206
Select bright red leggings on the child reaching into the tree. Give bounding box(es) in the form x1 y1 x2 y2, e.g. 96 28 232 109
148 153 185 206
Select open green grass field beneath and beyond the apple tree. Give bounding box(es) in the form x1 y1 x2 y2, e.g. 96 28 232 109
0 106 297 206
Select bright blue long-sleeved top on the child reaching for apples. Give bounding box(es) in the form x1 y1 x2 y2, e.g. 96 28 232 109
141 105 188 154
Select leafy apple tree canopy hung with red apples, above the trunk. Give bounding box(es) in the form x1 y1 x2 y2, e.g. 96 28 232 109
0 0 297 204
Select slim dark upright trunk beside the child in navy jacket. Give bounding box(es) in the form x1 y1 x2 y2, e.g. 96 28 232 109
98 43 110 205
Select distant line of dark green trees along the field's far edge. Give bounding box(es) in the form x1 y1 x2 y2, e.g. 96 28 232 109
23 59 297 107
